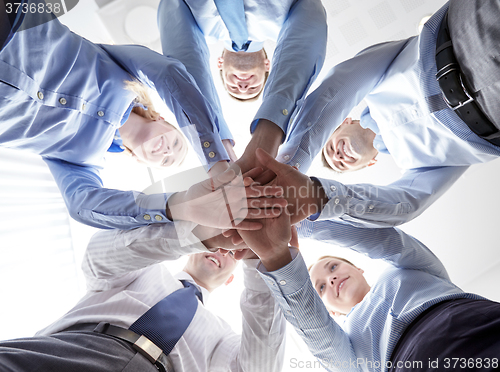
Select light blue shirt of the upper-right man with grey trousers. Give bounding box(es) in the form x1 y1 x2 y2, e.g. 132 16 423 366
278 5 500 227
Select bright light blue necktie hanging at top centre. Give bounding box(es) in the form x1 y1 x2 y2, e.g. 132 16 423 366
214 0 250 52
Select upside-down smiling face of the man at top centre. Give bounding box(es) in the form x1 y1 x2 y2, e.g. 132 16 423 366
217 49 270 100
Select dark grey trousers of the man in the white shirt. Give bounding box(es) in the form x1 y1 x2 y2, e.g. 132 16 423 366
0 332 158 372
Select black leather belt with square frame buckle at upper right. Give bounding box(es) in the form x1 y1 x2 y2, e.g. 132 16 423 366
436 13 500 146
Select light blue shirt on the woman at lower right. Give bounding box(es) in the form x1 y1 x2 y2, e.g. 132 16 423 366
258 220 484 371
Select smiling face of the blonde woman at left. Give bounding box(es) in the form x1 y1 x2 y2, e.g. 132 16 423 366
120 112 188 167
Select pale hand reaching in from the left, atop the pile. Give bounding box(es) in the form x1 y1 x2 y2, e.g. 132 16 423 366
167 166 286 230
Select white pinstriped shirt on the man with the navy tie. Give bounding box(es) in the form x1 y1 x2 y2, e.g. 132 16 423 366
38 224 285 372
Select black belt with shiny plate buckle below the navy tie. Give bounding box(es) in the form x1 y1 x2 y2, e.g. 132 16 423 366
61 322 173 372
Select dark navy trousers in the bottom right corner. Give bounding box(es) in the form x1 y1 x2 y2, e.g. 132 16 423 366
389 299 500 372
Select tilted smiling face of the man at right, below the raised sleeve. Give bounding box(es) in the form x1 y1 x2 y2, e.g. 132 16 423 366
323 118 378 172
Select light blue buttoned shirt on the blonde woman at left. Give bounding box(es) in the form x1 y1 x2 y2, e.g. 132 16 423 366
0 7 223 229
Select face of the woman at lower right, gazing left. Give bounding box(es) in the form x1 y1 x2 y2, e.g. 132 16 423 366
310 257 370 315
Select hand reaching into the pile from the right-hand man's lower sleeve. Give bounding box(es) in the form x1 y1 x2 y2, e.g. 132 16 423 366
255 149 328 224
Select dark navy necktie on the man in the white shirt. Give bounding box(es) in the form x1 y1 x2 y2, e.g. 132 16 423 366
129 280 202 355
